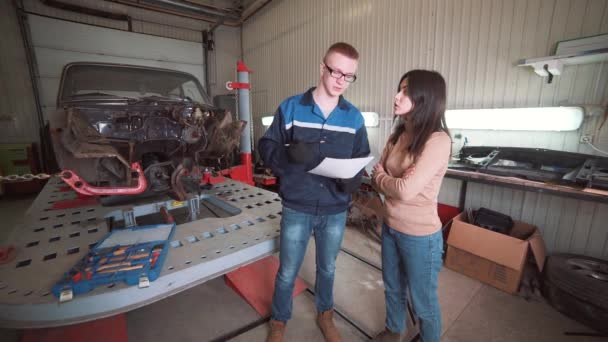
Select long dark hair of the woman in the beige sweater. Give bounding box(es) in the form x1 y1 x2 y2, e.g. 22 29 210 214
389 70 450 161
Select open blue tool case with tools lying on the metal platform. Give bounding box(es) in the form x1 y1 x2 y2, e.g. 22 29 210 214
52 223 175 298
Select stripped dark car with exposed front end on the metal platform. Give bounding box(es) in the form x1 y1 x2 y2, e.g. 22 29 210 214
49 62 246 200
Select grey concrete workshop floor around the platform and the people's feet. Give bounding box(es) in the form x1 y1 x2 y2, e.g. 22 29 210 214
0 194 608 342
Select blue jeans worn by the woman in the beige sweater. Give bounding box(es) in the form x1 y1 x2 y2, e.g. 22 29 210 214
382 224 443 342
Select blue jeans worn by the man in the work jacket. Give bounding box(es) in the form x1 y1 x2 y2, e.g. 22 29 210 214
271 207 346 322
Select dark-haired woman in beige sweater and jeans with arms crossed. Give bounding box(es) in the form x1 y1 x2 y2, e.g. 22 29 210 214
372 70 452 342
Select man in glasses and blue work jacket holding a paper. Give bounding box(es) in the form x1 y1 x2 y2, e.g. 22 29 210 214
259 43 370 342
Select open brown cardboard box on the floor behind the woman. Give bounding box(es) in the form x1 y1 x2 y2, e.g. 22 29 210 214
445 213 546 293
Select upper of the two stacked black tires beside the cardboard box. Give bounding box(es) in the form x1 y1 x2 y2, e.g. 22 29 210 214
543 254 608 310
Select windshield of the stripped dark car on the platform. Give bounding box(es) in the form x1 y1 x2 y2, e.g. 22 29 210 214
57 63 212 106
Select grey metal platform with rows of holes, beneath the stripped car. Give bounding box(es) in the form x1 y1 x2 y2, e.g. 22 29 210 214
0 179 281 328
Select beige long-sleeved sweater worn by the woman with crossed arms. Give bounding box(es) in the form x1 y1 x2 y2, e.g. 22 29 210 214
373 132 452 236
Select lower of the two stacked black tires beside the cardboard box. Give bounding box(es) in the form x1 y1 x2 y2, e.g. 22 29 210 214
543 280 608 334
